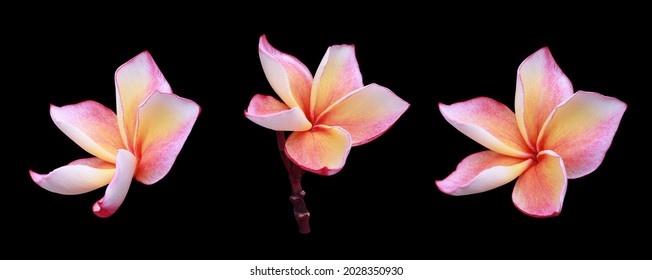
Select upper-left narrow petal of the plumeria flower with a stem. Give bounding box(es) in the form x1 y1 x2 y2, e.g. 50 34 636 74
258 35 312 112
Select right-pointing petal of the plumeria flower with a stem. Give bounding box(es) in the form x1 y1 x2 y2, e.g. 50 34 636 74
316 84 410 146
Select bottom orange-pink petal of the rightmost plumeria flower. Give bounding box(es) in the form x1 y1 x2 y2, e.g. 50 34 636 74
512 150 568 218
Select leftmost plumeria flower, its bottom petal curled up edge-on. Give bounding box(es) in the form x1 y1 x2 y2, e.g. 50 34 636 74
30 51 200 217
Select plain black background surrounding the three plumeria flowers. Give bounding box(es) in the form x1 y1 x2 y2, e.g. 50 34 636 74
0 7 652 259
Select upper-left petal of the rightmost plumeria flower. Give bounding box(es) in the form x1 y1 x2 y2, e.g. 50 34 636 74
439 97 531 158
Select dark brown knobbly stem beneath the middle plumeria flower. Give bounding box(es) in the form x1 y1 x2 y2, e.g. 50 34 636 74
276 131 310 234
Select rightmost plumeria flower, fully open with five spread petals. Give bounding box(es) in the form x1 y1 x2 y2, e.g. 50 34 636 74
436 47 627 217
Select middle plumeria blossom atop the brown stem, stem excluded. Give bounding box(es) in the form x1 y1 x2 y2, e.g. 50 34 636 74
245 35 410 175
